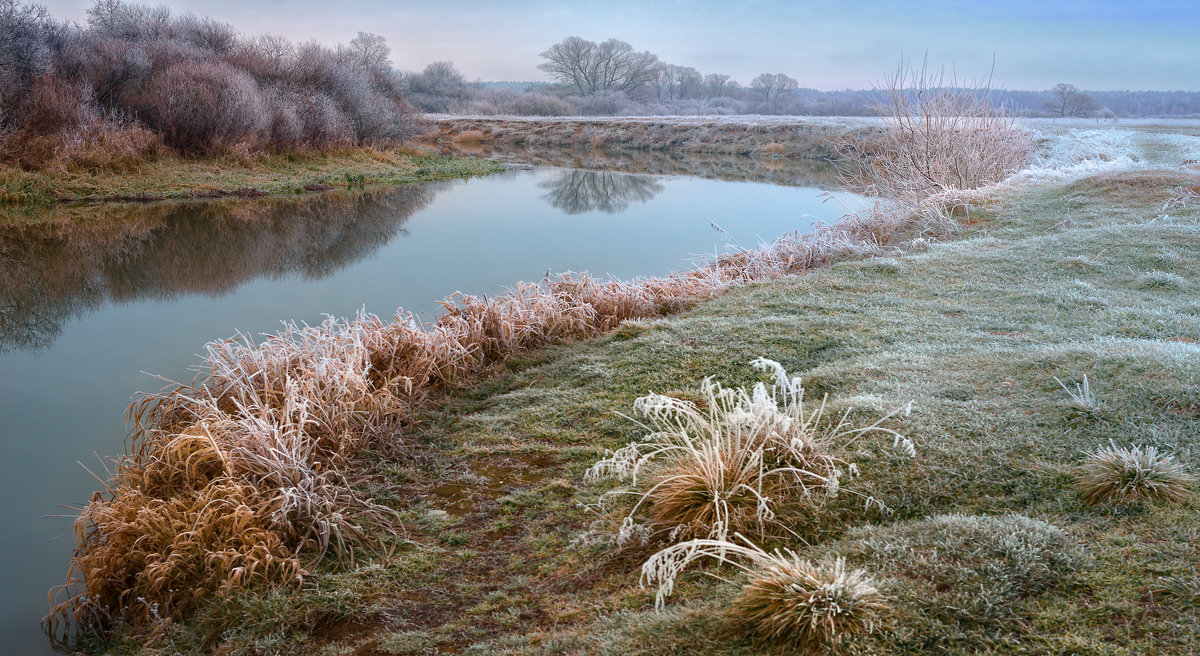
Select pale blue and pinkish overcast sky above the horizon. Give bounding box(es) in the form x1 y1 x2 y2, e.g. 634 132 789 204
42 0 1200 90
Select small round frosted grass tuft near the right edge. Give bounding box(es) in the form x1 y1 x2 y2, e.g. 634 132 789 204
1075 441 1195 505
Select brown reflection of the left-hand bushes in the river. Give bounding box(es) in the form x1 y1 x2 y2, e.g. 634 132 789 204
0 185 442 353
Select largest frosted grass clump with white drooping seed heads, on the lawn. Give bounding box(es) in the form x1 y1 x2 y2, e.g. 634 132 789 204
587 357 913 541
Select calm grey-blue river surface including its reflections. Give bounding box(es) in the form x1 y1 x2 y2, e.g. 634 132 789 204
0 160 862 654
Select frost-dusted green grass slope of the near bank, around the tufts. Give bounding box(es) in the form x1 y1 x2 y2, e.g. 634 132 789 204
98 165 1200 655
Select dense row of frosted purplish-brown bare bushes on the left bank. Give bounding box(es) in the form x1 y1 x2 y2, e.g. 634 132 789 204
0 0 418 168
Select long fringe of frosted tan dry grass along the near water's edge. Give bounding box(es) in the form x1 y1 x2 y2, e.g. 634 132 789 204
47 163 904 637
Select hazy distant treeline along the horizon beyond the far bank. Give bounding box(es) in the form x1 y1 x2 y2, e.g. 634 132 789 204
434 36 1200 118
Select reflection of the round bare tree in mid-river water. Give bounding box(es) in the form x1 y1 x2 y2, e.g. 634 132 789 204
540 169 662 215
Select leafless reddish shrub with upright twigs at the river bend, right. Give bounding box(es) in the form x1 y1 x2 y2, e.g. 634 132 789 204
841 61 1032 209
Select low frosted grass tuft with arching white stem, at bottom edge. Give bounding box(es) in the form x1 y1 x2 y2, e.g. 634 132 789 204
642 538 889 652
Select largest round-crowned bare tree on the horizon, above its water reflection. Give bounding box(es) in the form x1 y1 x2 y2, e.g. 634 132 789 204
538 36 660 96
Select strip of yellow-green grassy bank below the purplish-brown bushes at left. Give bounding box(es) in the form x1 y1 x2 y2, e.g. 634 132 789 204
0 149 502 204
